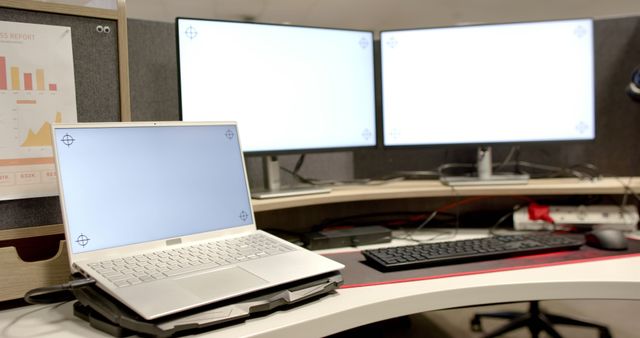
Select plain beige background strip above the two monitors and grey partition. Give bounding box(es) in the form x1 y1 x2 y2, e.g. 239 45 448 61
124 0 640 31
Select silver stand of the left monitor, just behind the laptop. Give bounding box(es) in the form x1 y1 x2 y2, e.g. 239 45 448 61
251 156 331 199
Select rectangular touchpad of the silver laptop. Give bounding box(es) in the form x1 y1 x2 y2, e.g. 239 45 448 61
175 267 267 299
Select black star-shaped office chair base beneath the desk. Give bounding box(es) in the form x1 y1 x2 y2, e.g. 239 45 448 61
471 300 611 338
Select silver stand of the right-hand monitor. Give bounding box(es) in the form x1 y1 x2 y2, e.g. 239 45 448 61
440 147 529 186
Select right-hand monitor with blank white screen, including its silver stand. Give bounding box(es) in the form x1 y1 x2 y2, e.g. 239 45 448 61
380 19 595 184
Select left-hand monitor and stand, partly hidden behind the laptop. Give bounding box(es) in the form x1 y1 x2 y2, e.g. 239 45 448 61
176 18 376 198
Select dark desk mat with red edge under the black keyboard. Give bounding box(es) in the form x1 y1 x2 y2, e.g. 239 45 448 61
325 239 640 289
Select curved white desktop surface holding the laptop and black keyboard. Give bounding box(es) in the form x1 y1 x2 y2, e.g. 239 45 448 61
0 232 640 338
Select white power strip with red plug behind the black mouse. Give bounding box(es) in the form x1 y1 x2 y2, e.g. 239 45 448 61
513 205 639 231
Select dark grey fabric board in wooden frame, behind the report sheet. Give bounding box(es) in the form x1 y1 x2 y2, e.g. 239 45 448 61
0 8 120 229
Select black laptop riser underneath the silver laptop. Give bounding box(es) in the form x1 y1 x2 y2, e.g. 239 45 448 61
73 272 343 337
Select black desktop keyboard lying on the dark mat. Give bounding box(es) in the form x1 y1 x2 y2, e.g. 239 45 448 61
362 234 584 271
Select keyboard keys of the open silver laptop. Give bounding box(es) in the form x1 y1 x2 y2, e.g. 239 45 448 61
89 233 293 287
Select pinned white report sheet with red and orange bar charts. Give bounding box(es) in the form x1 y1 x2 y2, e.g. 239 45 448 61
0 21 78 200
